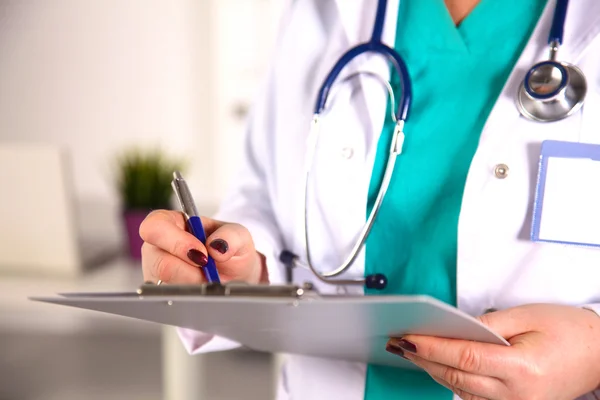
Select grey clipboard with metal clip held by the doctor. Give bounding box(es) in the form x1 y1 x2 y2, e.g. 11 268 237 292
30 282 509 369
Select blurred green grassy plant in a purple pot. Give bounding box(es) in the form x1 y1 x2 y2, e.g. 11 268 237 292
117 148 183 260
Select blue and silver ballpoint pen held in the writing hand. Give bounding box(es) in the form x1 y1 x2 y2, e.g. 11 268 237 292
171 171 221 283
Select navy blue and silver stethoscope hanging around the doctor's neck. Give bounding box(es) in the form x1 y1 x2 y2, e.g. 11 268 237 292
279 0 586 290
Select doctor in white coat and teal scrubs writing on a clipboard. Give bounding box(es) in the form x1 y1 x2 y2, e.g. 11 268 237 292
140 0 600 400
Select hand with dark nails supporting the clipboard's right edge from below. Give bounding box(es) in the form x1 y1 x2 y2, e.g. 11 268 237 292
387 304 600 400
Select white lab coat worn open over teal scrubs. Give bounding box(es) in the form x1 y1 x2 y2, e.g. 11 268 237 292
180 0 600 400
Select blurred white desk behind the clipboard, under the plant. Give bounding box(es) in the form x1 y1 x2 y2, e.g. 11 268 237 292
0 259 279 400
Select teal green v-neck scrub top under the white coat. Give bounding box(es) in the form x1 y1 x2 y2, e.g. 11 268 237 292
364 0 546 400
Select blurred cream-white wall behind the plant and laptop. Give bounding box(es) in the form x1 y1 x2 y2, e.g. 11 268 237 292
0 0 285 216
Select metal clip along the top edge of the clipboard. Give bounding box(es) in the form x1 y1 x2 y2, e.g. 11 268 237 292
137 282 318 299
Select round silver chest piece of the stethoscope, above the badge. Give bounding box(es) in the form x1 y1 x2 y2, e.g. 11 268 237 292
517 60 587 122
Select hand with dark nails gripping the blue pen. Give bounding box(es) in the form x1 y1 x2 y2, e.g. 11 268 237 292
140 210 267 284
